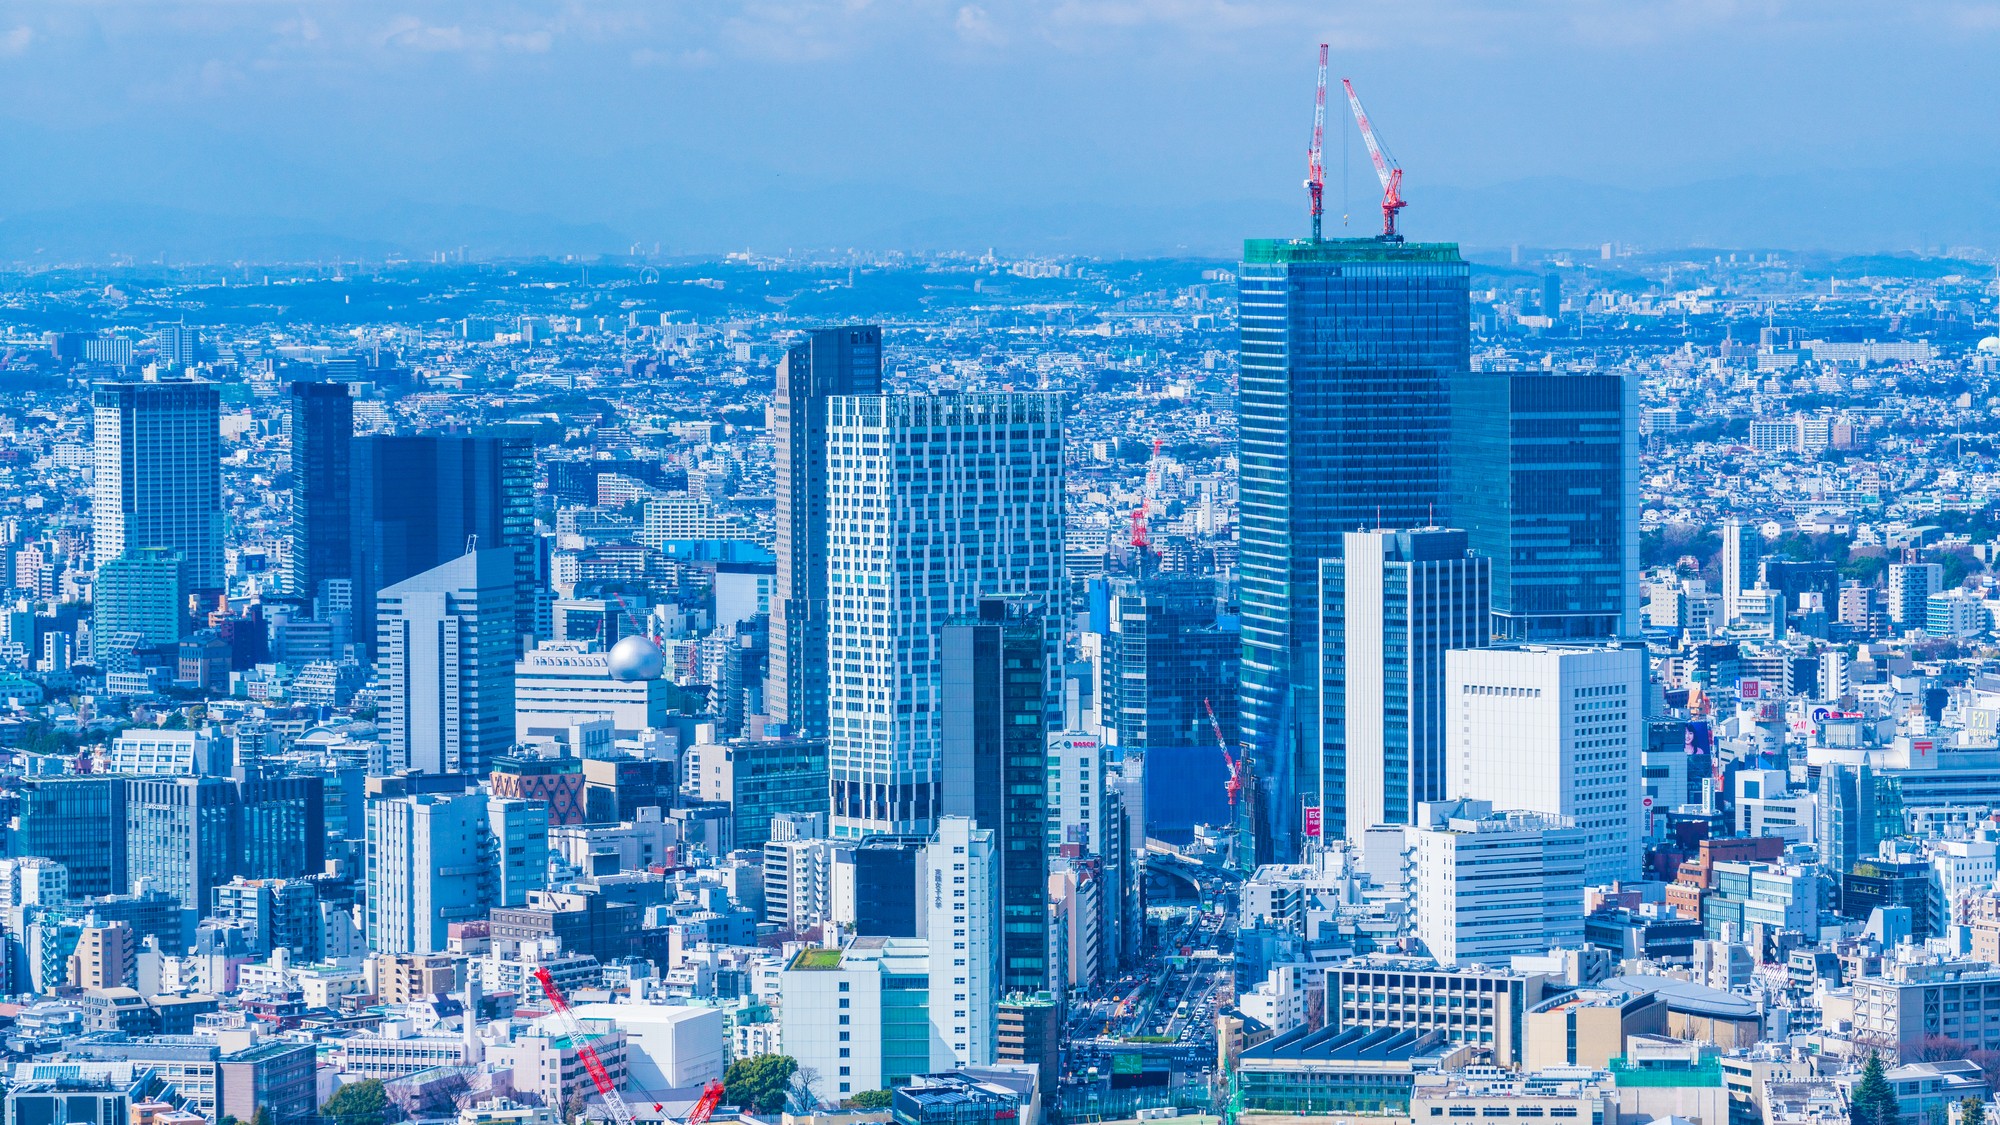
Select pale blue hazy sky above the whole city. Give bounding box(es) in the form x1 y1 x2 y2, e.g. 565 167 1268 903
0 0 2000 252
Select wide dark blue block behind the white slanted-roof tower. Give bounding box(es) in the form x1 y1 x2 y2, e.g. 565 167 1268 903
352 426 548 645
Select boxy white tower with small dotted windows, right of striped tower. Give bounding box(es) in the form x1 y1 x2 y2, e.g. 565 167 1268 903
1446 645 1646 887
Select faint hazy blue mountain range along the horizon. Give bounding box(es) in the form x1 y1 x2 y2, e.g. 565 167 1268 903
0 168 2000 264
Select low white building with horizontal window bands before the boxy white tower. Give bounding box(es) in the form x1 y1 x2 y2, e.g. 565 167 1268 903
1406 801 1588 965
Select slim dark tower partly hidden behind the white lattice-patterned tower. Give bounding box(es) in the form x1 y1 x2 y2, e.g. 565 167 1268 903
764 324 882 739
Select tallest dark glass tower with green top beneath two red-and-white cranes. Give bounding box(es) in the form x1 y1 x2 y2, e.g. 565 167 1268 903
1238 238 1470 863
